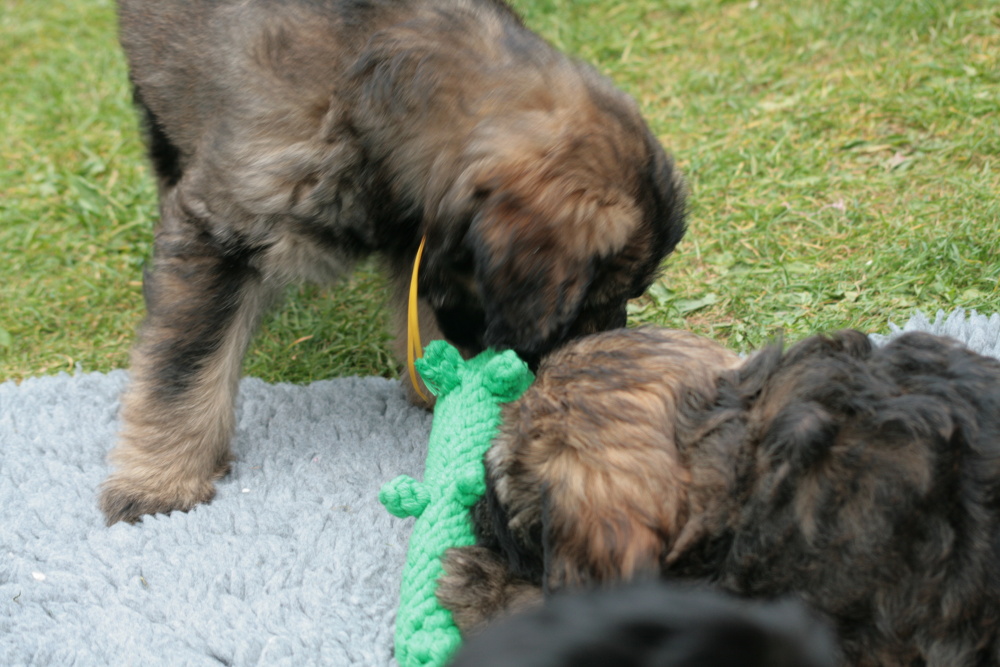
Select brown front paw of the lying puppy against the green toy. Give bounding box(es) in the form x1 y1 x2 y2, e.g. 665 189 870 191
437 547 542 637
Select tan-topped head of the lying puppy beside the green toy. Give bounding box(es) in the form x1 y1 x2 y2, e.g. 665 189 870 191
477 328 740 590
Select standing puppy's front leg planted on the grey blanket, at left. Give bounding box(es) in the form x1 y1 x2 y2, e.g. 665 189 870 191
100 196 272 525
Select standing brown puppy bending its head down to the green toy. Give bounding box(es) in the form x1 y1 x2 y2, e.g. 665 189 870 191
101 0 684 523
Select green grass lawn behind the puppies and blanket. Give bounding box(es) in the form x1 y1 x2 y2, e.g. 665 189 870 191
0 0 1000 382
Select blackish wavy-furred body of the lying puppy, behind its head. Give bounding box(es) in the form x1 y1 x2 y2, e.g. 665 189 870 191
722 332 1000 667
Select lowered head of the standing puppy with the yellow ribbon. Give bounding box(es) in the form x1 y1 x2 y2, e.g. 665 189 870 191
421 54 684 359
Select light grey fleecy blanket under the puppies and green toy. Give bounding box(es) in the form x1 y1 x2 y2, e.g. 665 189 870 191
0 311 1000 667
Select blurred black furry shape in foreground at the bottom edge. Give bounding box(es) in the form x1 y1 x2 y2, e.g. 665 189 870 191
451 583 836 667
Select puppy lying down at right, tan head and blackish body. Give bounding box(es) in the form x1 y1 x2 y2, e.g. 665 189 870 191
439 329 1000 667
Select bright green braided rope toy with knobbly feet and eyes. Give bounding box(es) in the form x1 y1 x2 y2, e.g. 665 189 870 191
379 341 534 667
